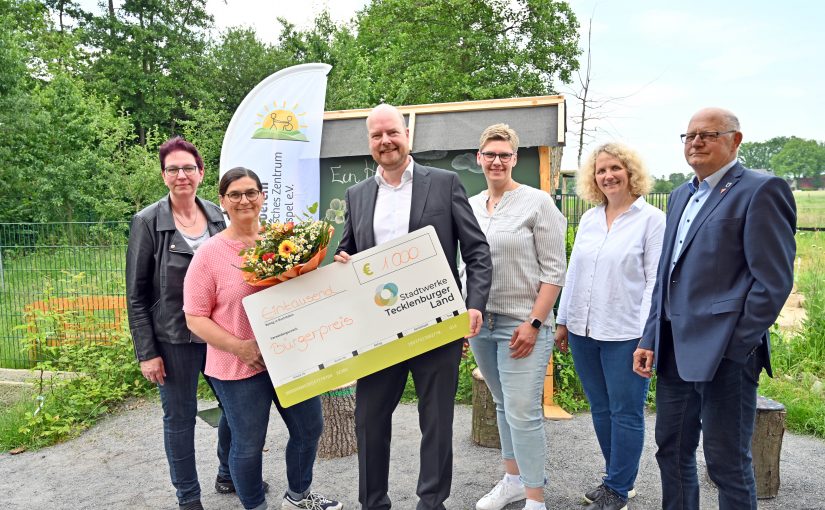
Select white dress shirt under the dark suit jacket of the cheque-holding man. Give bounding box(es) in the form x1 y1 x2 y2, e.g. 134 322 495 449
372 158 414 245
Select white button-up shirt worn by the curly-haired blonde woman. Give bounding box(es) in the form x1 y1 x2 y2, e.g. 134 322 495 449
556 197 665 340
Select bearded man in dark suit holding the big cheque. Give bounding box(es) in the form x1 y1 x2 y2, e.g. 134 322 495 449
335 104 492 510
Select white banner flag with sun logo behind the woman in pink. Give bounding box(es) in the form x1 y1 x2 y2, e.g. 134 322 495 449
220 64 332 222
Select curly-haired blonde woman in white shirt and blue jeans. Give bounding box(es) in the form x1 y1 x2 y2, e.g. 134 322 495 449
556 143 665 510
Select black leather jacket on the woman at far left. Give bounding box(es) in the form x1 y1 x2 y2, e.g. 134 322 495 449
126 195 226 361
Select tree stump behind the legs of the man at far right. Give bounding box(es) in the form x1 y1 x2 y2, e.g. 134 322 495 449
751 396 785 499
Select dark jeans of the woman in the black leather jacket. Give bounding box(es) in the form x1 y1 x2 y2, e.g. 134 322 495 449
157 342 231 504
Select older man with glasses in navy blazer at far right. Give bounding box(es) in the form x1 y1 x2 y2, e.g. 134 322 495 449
633 108 796 510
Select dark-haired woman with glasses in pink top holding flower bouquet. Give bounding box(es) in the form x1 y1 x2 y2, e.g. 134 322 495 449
183 167 342 510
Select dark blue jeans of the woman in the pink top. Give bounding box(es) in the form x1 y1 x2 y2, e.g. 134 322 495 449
212 372 324 508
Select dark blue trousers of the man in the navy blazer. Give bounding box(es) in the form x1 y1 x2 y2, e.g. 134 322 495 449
656 327 761 510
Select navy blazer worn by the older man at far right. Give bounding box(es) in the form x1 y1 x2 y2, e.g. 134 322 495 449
639 162 796 381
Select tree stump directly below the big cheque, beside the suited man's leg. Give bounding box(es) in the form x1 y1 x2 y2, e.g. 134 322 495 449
318 382 358 459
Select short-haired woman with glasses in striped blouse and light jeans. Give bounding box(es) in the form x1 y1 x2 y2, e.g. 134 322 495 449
470 124 567 510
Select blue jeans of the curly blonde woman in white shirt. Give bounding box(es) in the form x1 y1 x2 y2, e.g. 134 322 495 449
568 333 649 499
